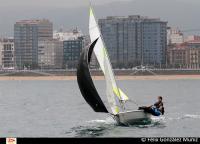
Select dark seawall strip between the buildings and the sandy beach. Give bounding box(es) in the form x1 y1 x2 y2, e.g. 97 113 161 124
0 69 200 77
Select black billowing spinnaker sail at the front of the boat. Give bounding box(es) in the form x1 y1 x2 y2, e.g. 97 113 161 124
77 38 108 113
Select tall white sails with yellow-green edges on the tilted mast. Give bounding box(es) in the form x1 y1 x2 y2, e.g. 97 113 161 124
89 7 128 114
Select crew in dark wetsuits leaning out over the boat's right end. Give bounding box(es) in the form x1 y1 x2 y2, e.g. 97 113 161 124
138 96 165 116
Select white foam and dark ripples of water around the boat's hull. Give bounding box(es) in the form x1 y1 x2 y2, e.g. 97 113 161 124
66 117 165 137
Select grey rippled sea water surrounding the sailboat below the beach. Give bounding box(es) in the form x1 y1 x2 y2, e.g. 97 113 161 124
0 80 200 137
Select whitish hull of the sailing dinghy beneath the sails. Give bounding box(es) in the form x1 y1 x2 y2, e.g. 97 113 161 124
115 110 151 125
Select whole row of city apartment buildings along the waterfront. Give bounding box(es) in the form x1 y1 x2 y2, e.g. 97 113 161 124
0 18 200 69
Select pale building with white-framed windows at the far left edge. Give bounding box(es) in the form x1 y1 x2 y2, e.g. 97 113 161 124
0 38 14 69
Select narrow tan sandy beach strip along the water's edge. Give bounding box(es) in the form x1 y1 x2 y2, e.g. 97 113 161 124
0 75 200 81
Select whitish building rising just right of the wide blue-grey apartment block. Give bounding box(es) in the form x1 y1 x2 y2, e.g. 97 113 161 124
167 27 184 45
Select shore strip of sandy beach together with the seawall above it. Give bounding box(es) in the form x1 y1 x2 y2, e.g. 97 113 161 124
0 69 200 80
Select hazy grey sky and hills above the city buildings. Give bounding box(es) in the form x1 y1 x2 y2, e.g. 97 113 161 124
0 0 200 37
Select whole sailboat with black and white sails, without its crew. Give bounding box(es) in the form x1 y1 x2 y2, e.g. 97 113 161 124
77 7 151 125
